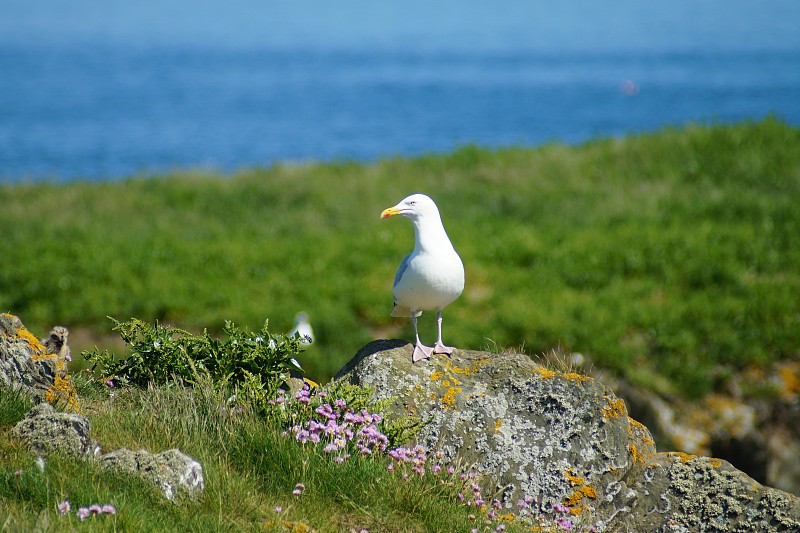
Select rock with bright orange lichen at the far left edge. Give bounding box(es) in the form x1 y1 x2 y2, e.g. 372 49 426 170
0 314 79 411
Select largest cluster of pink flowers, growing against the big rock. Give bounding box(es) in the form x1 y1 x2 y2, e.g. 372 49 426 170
282 384 389 463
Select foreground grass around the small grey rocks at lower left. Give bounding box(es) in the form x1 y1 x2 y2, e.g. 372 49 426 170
0 376 522 532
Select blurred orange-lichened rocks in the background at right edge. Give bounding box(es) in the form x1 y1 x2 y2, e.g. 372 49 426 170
597 361 800 495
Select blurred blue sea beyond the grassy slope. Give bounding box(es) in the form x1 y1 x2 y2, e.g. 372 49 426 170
0 0 800 182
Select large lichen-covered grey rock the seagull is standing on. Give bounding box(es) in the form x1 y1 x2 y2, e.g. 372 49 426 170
337 341 800 531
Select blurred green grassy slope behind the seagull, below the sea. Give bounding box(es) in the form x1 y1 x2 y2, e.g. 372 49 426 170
0 118 800 394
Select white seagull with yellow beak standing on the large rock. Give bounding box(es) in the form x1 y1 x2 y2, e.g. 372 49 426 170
381 194 464 363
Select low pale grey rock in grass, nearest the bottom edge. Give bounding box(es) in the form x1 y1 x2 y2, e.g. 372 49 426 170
100 448 204 500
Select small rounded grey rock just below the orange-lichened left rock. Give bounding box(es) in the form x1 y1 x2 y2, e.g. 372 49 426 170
12 403 100 458
